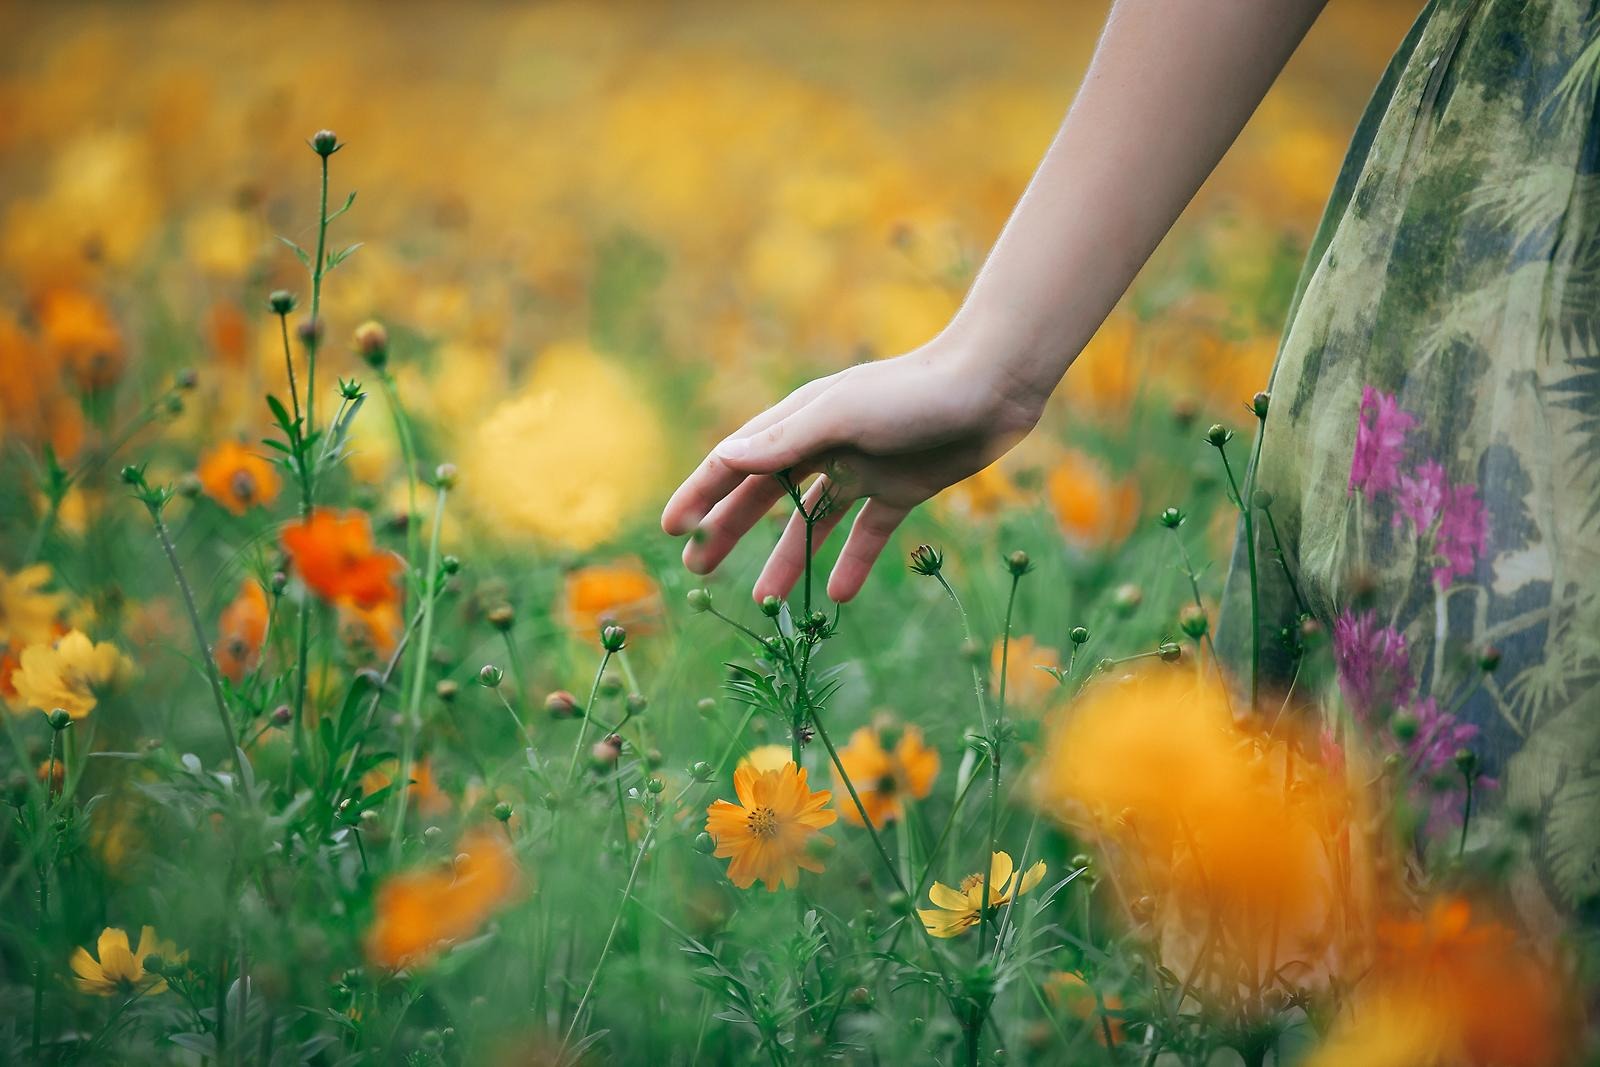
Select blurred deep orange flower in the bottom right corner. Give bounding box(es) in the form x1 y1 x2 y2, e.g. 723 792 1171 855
1309 897 1576 1067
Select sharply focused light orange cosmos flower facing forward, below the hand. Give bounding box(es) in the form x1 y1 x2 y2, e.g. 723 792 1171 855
706 763 838 893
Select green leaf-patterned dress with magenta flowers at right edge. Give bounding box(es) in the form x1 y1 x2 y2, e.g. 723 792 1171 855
1219 0 1600 921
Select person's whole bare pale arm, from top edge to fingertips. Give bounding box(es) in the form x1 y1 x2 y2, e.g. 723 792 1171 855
661 0 1325 601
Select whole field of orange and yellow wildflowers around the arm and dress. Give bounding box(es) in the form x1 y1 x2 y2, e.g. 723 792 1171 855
0 0 1592 1067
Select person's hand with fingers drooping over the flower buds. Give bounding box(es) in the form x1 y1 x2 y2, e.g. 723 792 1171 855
661 341 1045 601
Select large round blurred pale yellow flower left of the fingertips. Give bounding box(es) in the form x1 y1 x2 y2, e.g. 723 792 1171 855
461 342 667 549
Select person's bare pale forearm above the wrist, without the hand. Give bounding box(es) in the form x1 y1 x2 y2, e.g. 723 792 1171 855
946 0 1325 403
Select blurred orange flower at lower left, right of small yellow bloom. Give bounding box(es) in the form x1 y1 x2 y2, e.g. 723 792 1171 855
366 830 518 968
